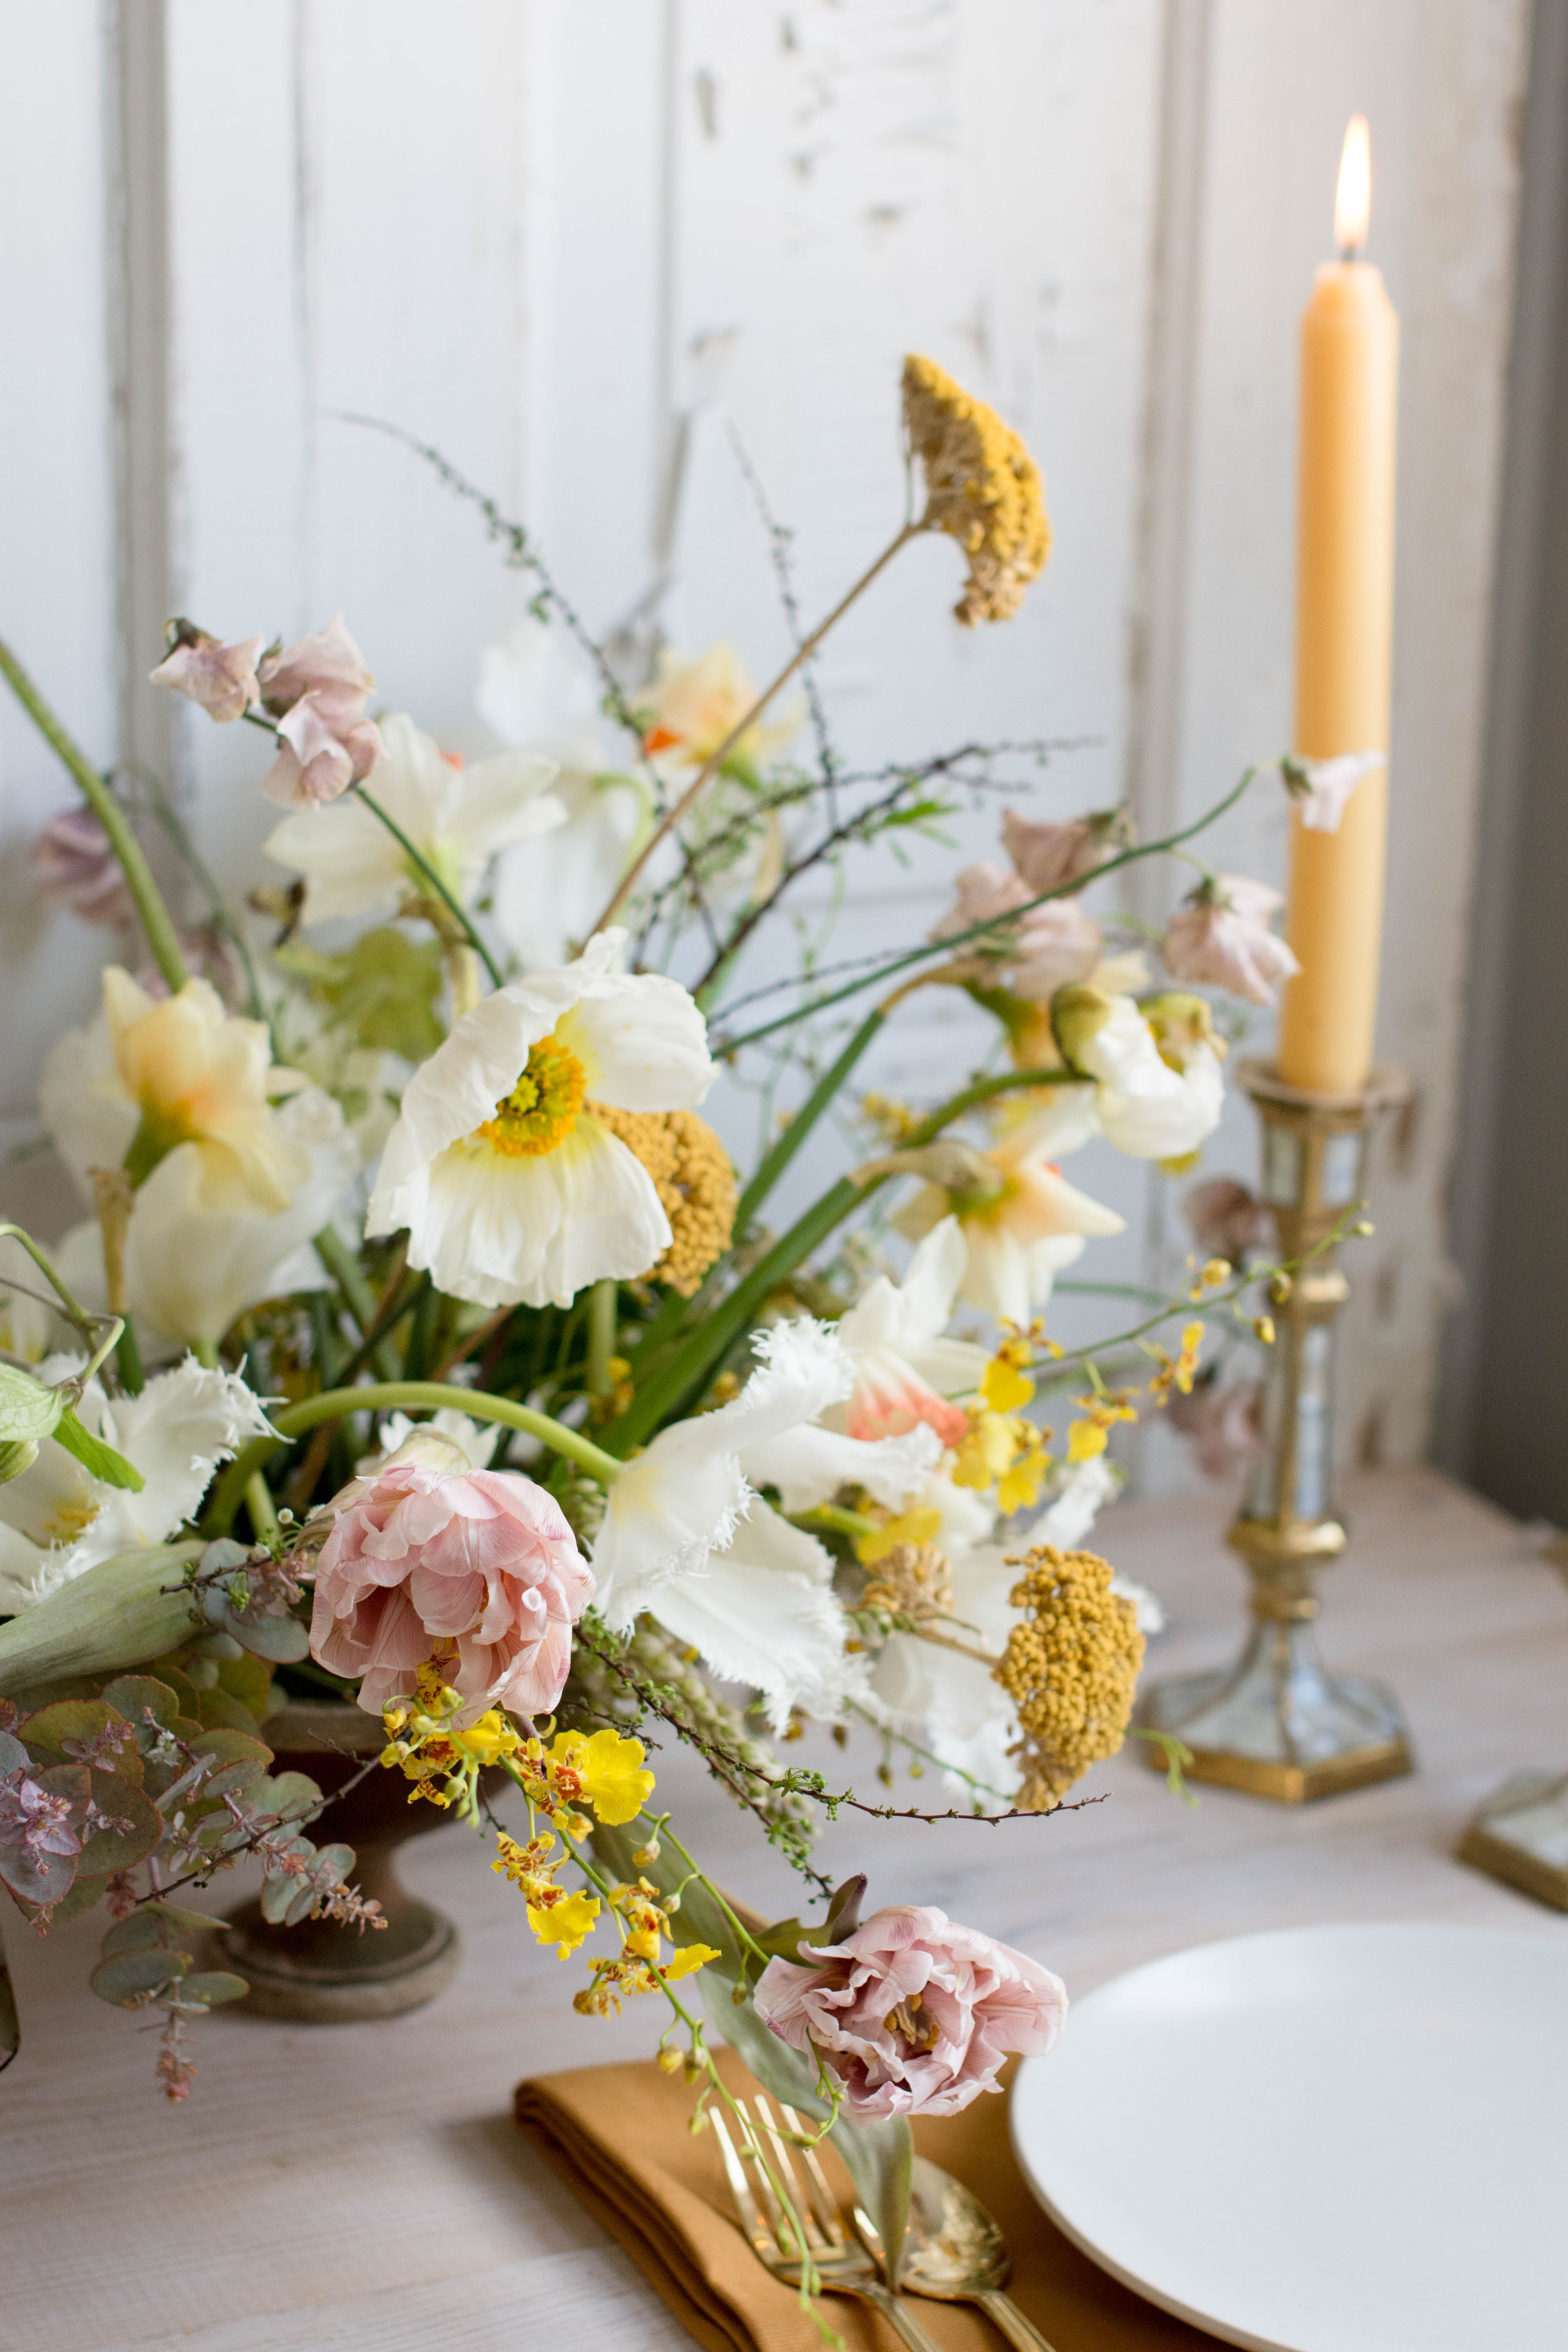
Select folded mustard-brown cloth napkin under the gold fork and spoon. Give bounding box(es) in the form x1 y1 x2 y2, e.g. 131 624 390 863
517 2051 1213 2352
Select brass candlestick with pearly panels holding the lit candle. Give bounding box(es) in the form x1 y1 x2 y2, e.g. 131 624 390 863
1138 1061 1415 1804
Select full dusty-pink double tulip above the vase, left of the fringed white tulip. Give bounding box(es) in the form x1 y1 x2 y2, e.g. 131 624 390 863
310 1439 595 1724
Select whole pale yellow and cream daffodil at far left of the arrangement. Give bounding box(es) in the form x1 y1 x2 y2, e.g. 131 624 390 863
40 964 308 1211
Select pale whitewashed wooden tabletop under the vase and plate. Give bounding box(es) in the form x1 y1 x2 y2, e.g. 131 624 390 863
0 1472 1568 2352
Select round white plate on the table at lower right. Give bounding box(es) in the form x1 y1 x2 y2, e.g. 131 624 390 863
1013 1926 1568 2352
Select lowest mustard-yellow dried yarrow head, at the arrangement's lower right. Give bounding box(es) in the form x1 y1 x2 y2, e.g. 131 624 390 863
995 1543 1143 1813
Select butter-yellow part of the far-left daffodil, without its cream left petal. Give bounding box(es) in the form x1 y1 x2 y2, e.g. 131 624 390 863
99 964 310 1214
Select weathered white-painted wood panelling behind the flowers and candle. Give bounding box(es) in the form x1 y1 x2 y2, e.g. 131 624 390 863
0 0 1528 1482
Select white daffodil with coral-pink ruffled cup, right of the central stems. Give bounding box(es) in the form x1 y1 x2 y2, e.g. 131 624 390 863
830 1216 985 1446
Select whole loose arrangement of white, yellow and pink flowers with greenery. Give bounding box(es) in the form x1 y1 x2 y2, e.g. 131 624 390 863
0 358 1333 2286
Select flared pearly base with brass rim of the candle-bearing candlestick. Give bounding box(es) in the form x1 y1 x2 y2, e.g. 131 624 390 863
1138 1618 1415 1804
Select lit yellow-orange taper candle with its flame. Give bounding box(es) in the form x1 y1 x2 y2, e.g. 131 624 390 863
1279 115 1399 1094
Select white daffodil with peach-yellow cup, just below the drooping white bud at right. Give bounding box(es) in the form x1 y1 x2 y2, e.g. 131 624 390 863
893 1087 1126 1324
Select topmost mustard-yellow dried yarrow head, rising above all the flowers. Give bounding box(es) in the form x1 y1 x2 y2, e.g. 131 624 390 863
903 353 1051 628
